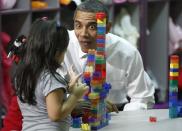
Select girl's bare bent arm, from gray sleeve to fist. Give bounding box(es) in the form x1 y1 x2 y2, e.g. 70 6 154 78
46 83 88 121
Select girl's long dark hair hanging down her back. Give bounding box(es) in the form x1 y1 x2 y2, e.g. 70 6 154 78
15 19 69 105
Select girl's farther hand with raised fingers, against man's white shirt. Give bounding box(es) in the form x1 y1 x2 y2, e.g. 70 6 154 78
68 66 82 92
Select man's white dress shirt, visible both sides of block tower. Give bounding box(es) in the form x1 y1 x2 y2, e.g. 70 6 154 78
64 31 154 110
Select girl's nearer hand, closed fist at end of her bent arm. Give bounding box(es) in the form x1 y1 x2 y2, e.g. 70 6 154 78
72 82 89 99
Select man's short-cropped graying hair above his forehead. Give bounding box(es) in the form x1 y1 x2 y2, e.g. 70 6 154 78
74 0 109 20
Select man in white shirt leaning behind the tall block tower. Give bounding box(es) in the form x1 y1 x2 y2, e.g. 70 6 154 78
65 0 154 111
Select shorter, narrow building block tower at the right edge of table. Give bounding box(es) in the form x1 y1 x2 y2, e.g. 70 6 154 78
169 55 182 118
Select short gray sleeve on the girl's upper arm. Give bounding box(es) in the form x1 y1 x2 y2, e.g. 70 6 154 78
43 73 67 96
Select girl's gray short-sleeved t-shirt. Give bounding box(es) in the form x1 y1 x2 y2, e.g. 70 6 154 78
18 72 70 131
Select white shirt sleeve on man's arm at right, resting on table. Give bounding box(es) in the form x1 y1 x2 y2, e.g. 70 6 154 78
124 50 154 110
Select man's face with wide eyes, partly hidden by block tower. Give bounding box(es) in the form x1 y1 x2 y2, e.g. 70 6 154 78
74 11 97 53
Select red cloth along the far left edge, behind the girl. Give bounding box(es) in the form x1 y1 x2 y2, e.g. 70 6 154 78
0 32 22 131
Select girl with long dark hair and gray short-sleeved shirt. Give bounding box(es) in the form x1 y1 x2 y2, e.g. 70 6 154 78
15 19 88 131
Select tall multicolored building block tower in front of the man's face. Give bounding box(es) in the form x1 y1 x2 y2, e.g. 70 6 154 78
82 12 111 130
